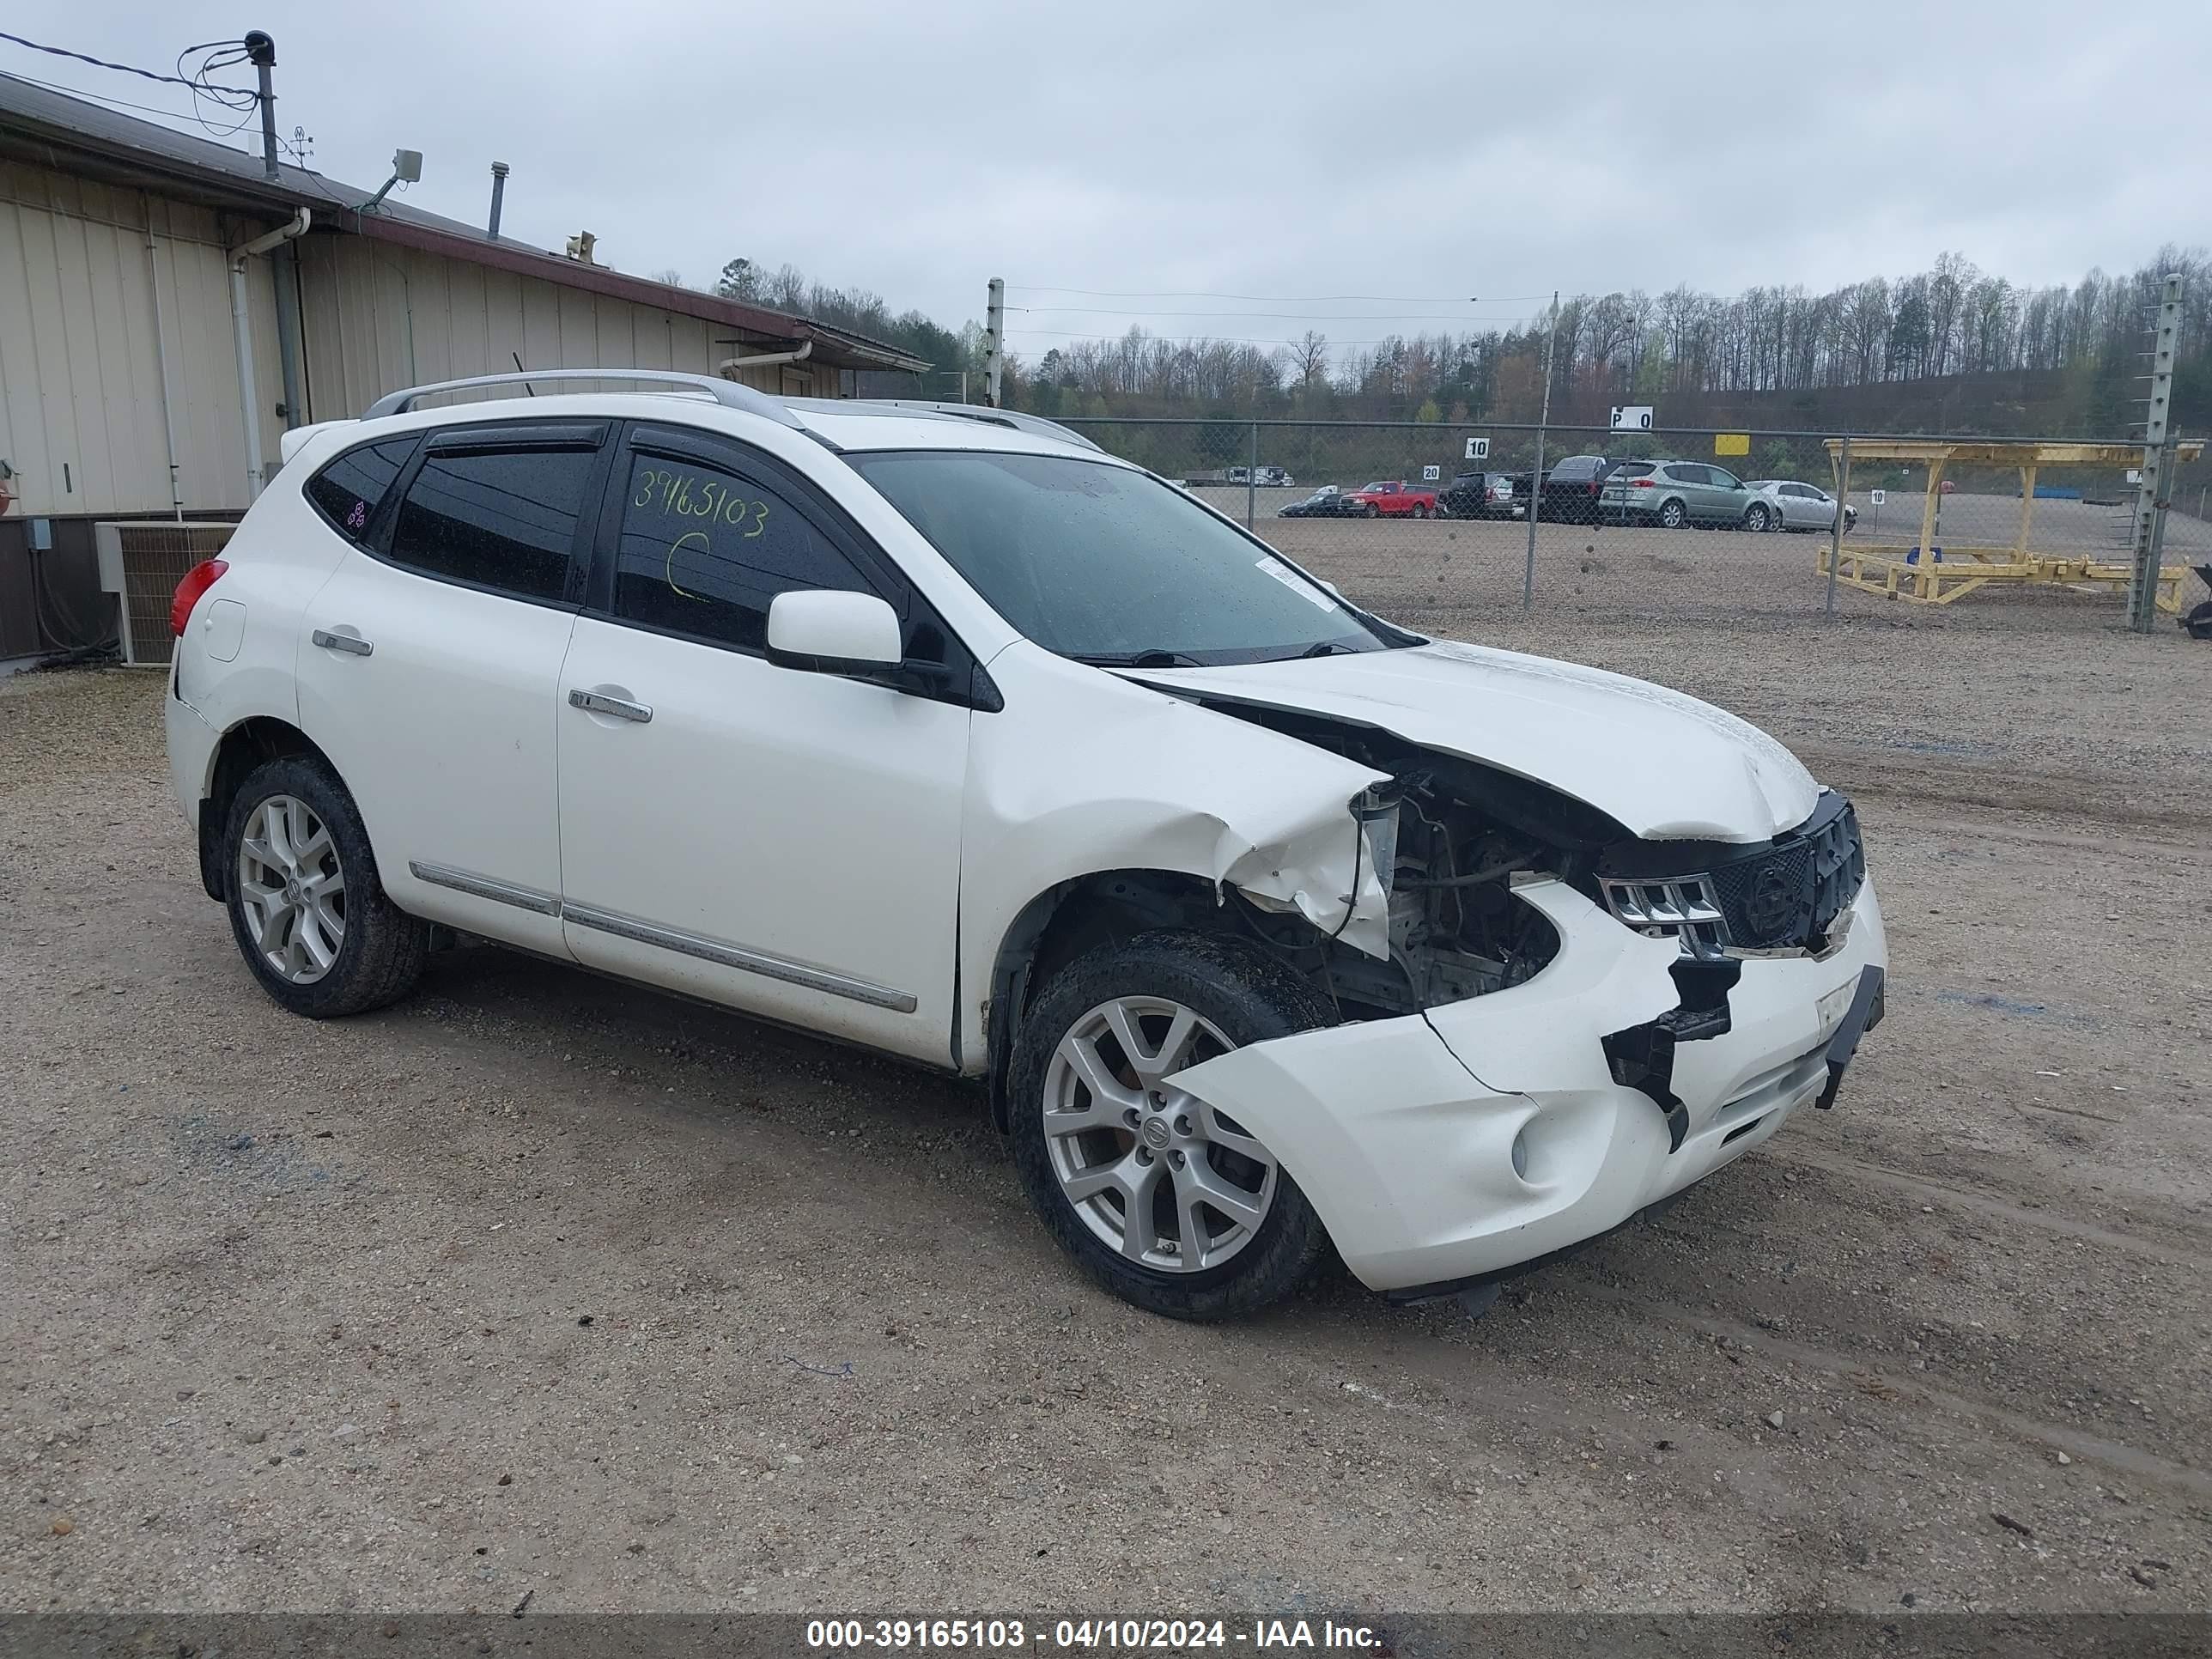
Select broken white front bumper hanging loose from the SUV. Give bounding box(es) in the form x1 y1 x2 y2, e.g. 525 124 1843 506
1175 880 1887 1298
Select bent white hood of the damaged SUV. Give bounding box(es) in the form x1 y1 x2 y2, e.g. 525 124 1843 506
1121 641 1820 841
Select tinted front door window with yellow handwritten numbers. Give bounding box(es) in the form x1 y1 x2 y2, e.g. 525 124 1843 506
615 453 874 650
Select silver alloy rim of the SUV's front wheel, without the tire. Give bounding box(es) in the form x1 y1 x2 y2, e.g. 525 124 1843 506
1040 995 1281 1274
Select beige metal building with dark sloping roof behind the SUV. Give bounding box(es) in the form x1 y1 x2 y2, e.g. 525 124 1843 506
0 76 927 661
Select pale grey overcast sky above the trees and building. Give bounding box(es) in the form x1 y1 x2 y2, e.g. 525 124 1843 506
0 0 2212 356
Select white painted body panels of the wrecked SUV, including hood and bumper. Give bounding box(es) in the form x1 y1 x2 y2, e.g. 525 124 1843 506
166 394 1885 1287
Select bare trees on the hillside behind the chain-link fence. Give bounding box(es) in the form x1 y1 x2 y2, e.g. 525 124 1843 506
685 248 2212 435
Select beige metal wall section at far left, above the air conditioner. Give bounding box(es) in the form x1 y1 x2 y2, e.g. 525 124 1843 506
0 161 283 518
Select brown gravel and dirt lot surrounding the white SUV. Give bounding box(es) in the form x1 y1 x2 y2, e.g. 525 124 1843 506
0 535 2212 1614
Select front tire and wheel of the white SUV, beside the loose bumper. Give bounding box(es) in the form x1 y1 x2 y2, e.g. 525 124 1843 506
1011 931 1336 1321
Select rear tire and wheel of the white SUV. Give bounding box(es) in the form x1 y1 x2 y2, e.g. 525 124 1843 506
223 754 429 1020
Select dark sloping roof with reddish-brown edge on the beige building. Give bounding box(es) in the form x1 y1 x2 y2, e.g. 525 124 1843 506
0 73 929 372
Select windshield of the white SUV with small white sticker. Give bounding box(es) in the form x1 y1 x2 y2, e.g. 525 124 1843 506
845 449 1401 668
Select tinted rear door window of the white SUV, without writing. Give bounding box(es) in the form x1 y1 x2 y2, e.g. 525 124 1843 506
392 449 592 602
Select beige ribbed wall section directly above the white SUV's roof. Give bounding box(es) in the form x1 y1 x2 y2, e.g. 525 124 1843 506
301 237 818 420
